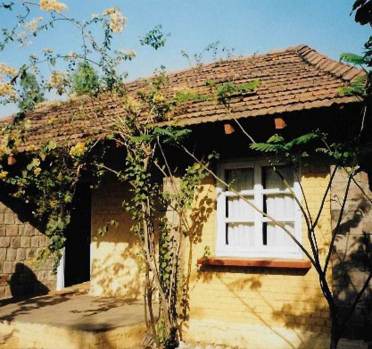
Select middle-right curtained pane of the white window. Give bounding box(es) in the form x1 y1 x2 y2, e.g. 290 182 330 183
264 194 296 221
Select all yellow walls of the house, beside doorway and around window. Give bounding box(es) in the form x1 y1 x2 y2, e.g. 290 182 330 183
91 167 331 349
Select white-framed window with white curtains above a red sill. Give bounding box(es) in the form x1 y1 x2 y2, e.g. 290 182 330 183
216 161 302 258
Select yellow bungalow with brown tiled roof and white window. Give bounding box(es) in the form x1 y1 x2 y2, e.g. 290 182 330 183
0 45 372 349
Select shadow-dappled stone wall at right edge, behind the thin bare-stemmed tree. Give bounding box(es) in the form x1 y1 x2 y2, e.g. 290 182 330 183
331 169 372 341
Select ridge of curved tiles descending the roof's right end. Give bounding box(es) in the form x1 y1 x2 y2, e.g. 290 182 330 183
296 45 365 82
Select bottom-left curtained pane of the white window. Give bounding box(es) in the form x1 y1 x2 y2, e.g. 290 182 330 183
226 223 254 248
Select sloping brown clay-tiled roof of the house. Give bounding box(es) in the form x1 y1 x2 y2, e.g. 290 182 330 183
5 45 361 149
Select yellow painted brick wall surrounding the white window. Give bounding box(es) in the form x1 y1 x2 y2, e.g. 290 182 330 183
185 163 331 349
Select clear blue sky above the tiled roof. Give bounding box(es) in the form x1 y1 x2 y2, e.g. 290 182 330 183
0 0 371 115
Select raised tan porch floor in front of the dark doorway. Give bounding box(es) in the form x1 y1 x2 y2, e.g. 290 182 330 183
0 285 145 349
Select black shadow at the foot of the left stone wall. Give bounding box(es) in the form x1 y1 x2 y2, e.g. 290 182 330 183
8 263 49 301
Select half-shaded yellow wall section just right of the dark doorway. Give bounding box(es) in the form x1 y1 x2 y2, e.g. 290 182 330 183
90 182 143 299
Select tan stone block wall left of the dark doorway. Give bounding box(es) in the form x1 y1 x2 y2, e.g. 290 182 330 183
0 202 56 298
